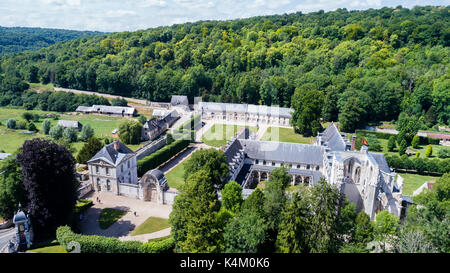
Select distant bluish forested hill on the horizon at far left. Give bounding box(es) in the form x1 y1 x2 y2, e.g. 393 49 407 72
0 26 102 55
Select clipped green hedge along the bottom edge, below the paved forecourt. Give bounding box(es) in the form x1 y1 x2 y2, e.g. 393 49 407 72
56 226 175 253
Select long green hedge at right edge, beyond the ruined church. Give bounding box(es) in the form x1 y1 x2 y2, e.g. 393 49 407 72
385 155 450 174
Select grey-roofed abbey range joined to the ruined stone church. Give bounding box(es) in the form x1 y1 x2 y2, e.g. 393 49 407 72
224 123 410 219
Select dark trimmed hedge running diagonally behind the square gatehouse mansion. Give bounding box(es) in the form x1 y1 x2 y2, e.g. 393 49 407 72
137 138 191 176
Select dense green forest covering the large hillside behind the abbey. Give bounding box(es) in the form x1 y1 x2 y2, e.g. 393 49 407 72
0 6 450 131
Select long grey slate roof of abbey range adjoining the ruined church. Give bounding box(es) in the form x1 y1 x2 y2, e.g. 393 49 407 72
239 140 323 165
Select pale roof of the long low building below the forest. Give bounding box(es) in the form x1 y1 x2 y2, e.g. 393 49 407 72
198 101 294 118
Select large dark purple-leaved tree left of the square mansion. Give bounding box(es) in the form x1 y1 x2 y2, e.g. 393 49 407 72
17 139 79 239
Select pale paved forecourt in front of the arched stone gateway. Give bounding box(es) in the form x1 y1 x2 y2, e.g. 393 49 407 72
81 192 172 240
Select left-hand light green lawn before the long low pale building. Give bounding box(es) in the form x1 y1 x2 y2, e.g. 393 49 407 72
202 124 257 147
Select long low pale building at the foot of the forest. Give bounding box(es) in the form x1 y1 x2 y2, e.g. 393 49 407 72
194 101 294 126
